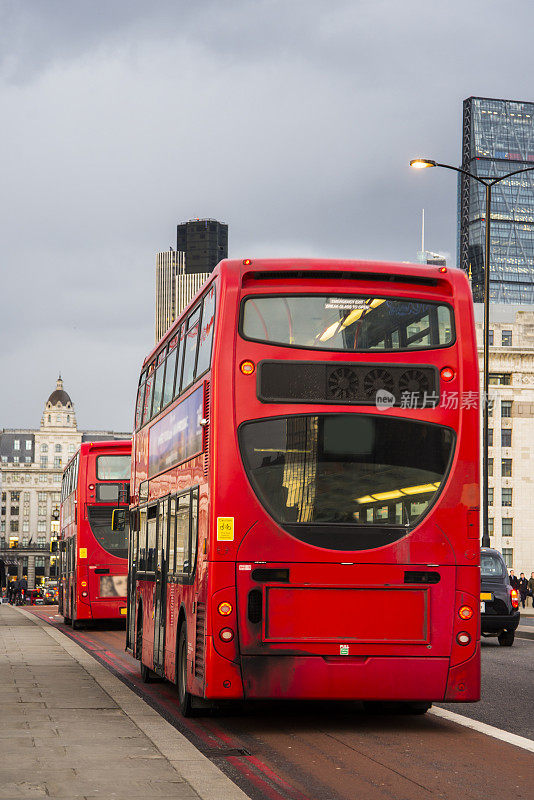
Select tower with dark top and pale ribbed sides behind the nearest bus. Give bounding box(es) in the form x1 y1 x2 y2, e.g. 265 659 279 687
155 219 228 342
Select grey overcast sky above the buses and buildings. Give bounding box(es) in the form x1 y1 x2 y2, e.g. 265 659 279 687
0 0 534 430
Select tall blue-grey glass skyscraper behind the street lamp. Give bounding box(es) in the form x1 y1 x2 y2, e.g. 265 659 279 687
458 97 534 303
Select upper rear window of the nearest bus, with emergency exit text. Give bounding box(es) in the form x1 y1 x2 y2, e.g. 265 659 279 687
241 295 454 352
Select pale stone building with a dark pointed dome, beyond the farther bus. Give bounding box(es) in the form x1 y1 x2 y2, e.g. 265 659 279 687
0 376 131 588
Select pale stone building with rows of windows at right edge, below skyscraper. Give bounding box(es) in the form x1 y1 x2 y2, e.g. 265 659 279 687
475 304 534 577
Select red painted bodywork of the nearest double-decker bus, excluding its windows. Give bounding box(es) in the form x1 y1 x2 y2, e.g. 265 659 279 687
127 259 480 702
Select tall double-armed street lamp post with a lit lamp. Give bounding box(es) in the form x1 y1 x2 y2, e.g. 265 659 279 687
410 158 534 547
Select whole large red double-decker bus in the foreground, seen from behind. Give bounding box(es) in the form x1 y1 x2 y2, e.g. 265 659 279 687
127 259 480 714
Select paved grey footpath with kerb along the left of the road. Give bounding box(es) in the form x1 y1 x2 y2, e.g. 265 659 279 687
0 605 251 800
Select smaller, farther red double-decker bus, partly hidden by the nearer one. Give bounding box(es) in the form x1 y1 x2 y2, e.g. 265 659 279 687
59 440 132 628
